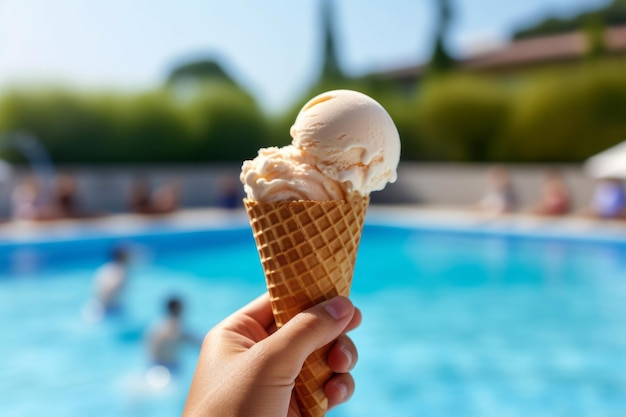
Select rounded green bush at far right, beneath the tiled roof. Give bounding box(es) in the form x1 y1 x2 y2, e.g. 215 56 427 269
495 63 626 162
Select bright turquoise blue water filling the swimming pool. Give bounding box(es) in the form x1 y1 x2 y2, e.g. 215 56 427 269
0 225 626 417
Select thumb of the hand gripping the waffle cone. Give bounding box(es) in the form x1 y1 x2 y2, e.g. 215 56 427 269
254 296 355 373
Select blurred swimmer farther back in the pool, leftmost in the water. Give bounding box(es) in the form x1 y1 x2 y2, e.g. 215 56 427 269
94 246 130 316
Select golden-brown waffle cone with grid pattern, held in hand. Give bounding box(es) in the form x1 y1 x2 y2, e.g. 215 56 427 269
244 197 369 417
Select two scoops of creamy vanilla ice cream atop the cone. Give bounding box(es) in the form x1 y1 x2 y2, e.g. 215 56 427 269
241 90 400 203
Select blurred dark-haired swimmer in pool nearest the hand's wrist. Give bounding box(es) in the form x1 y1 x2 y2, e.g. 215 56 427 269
147 297 202 373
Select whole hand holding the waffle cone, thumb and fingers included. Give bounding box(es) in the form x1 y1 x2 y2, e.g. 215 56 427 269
183 294 361 417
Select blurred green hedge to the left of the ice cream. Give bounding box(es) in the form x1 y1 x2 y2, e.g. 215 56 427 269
0 83 267 162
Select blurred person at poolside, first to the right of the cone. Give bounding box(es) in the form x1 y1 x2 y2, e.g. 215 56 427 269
478 166 517 214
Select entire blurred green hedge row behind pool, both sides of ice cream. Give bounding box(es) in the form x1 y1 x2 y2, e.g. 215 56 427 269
0 58 626 163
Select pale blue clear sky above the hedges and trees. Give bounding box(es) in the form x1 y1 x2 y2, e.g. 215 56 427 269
0 0 608 112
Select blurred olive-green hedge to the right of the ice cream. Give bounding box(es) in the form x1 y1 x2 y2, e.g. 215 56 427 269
408 60 626 162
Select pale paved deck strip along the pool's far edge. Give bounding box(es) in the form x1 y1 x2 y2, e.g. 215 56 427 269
0 205 626 244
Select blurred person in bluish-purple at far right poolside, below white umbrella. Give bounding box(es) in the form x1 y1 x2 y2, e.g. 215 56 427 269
586 177 626 219
